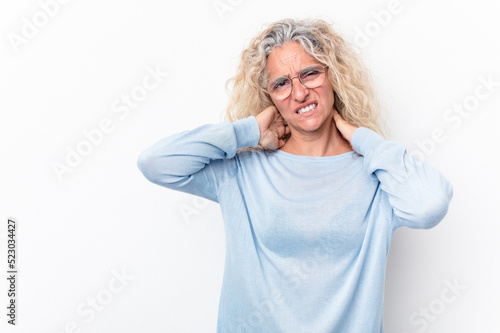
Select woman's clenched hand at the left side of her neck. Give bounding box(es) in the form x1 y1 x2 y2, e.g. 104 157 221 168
255 105 290 150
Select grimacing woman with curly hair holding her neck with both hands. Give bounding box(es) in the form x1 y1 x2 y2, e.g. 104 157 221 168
138 20 452 333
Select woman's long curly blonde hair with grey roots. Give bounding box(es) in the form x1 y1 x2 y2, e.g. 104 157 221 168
225 19 383 135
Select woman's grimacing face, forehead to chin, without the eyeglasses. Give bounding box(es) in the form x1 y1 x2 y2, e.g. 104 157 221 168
267 42 335 136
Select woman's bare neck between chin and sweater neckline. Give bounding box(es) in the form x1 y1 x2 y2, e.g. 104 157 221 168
281 119 352 156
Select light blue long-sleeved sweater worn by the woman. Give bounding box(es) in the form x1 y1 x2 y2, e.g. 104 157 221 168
138 116 452 333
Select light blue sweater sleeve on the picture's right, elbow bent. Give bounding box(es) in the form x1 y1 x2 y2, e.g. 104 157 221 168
352 127 453 229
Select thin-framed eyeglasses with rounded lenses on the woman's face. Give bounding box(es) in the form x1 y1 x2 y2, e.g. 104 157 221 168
264 65 328 100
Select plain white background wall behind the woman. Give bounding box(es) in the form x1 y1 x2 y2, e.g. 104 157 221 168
0 0 500 333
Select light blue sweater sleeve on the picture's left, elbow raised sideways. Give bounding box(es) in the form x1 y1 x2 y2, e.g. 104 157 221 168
137 116 260 202
